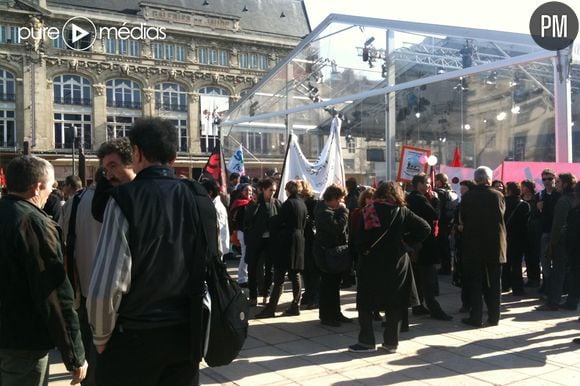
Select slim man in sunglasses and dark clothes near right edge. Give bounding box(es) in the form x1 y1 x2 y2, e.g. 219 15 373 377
537 169 560 300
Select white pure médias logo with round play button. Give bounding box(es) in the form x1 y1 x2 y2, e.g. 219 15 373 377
18 16 167 51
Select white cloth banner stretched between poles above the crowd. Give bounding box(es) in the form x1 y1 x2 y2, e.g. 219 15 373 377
278 117 345 201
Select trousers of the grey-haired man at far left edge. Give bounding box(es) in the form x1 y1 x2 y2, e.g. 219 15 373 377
0 349 48 386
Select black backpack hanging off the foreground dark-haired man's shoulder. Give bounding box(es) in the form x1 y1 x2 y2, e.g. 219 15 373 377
183 180 249 367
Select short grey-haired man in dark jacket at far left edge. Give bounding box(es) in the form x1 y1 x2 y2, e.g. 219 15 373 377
0 156 87 386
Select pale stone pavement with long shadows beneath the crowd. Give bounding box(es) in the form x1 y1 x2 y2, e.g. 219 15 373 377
50 270 580 386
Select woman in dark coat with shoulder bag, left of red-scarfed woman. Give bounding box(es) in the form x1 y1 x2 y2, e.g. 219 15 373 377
314 185 351 327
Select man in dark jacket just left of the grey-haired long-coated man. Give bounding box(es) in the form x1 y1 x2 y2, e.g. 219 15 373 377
407 173 453 320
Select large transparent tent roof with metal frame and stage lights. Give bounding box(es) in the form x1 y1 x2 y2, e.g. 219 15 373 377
222 14 580 179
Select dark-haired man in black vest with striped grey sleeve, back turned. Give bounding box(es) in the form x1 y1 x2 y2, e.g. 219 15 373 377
87 118 217 386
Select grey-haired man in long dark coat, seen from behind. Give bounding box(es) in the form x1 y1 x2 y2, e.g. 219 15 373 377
460 166 507 327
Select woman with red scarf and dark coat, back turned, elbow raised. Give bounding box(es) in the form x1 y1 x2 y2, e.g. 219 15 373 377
349 182 431 353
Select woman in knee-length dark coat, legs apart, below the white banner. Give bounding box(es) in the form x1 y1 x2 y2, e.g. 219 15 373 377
256 181 308 318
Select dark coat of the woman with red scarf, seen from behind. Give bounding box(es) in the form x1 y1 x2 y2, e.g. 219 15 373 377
355 202 431 310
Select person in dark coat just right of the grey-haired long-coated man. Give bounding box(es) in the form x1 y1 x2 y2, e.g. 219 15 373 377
501 182 530 296
